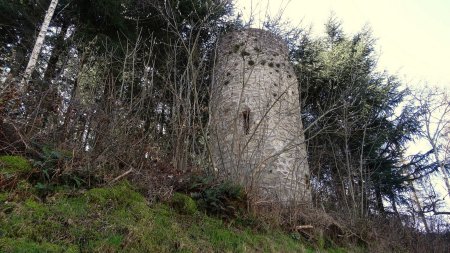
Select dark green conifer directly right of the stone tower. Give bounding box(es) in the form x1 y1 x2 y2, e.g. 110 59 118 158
291 19 420 216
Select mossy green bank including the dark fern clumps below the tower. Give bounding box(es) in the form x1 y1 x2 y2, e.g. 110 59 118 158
0 156 366 252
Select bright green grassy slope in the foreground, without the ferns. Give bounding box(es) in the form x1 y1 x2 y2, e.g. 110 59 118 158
0 182 326 252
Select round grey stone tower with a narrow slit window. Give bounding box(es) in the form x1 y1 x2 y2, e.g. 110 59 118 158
210 29 311 204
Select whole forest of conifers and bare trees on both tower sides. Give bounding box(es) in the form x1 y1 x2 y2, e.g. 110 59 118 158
0 0 450 252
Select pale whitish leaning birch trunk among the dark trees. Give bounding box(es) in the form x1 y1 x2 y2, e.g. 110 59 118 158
22 0 58 90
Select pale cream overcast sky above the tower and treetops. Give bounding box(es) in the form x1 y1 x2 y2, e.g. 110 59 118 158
236 0 450 88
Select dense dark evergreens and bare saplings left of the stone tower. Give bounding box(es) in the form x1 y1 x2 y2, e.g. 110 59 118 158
0 0 236 178
